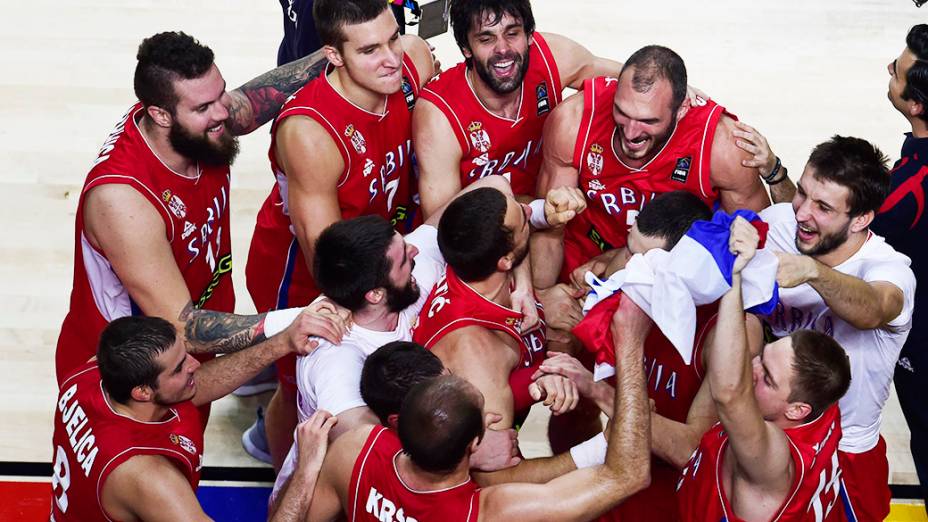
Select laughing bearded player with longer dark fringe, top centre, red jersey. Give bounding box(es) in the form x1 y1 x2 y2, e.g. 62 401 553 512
413 0 621 216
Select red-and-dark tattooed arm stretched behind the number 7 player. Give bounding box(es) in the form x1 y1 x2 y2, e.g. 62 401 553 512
226 50 328 135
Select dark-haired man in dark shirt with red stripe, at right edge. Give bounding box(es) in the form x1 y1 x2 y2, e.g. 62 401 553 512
870 24 928 501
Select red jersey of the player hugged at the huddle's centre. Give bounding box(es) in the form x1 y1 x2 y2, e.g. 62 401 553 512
412 267 547 420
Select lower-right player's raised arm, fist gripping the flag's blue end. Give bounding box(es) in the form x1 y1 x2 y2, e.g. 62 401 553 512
706 217 793 492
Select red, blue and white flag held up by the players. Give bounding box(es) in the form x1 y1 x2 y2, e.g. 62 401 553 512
573 210 778 381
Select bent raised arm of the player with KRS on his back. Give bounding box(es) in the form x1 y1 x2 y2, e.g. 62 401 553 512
480 292 651 521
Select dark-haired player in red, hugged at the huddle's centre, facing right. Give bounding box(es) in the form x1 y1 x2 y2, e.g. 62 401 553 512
413 183 582 428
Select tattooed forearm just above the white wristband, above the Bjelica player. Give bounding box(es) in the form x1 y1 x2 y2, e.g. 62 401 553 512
177 302 267 353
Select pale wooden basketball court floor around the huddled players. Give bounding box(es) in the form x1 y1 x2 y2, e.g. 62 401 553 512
0 0 928 520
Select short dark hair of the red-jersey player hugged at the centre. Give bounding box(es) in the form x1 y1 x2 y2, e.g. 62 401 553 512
438 187 514 282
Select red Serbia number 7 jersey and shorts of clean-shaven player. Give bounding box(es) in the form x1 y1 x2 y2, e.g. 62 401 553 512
245 56 419 312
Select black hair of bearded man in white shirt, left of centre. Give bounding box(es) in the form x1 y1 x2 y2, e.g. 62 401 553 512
313 216 395 312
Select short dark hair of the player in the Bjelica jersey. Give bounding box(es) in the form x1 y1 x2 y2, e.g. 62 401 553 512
97 316 177 404
